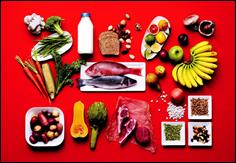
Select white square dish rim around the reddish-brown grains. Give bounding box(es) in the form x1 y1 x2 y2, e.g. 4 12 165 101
188 96 212 120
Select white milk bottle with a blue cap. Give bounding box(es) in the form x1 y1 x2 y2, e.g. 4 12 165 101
78 12 93 55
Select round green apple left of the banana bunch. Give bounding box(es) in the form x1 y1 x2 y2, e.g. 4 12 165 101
168 45 184 62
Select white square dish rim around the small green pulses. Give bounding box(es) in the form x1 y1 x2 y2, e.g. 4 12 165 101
161 122 185 146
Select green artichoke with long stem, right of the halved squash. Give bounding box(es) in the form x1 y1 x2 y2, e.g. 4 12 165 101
88 102 107 149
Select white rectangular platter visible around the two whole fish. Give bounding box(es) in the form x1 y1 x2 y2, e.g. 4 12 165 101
80 62 146 92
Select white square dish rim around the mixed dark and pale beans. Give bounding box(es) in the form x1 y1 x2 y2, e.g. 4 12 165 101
188 122 212 146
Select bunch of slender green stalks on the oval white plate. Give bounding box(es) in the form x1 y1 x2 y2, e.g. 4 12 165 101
34 35 71 57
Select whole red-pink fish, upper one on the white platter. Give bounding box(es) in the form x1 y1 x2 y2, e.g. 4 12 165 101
85 61 142 77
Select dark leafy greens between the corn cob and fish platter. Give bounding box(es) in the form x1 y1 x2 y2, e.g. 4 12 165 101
52 51 86 94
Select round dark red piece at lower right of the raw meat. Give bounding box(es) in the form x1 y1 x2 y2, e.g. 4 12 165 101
135 127 151 146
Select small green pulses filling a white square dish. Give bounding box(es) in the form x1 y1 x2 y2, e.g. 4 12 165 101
164 124 182 140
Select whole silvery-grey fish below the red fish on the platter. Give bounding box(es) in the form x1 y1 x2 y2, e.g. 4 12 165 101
76 76 137 89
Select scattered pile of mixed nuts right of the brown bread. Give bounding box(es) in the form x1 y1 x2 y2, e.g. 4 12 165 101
108 14 141 59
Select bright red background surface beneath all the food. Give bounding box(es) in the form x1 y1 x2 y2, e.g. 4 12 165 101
1 1 235 161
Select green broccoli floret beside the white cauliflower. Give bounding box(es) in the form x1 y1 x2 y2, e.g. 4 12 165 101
45 16 64 35
